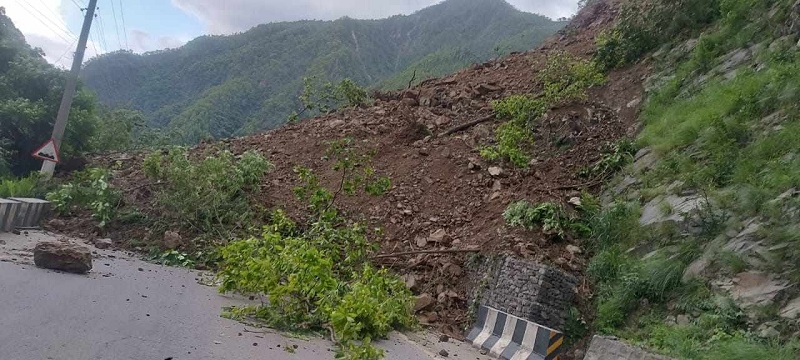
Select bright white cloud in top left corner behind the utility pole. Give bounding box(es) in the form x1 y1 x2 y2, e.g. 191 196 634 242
3 0 102 68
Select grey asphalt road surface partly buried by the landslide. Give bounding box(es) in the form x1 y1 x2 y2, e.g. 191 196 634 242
0 233 486 360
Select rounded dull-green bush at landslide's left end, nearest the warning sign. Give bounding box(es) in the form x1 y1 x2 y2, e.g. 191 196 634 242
142 148 272 234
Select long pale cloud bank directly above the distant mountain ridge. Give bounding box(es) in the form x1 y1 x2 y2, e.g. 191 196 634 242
172 0 578 34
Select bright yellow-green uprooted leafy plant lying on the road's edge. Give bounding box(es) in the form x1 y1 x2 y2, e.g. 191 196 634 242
214 140 414 359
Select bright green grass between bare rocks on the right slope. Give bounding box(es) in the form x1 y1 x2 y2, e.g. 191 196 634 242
586 0 800 360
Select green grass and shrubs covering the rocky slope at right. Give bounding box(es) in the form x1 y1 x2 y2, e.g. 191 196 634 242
586 0 800 359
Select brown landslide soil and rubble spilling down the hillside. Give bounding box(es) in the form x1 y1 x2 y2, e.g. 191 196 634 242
47 0 650 350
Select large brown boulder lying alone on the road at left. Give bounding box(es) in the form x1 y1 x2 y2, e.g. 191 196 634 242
33 242 92 274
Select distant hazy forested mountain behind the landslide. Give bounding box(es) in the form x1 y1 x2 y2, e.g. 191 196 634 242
84 0 563 143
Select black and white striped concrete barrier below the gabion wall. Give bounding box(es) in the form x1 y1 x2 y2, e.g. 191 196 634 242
467 305 564 360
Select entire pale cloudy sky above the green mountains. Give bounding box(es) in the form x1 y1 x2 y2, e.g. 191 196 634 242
0 0 578 68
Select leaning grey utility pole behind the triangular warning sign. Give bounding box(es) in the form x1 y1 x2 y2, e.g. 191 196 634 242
42 0 97 178
